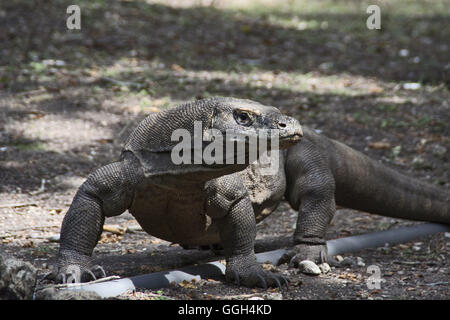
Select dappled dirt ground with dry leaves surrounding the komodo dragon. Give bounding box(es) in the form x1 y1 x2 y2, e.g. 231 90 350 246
0 0 450 300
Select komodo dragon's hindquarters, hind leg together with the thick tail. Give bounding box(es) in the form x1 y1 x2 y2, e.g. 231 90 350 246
281 127 450 265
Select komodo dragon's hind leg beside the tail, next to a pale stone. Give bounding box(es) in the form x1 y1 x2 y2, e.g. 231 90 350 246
280 141 336 266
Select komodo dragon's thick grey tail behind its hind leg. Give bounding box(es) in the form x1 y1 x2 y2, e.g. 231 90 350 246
330 141 450 223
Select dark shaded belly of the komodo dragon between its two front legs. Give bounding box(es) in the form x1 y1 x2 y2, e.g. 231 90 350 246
129 184 219 245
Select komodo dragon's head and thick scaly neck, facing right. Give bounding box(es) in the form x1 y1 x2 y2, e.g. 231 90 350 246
124 97 303 179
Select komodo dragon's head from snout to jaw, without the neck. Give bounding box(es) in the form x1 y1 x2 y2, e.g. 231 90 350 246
193 98 303 169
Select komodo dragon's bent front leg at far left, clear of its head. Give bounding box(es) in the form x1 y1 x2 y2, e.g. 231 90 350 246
53 154 143 283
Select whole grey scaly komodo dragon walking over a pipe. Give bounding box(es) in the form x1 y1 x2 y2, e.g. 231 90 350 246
53 98 450 287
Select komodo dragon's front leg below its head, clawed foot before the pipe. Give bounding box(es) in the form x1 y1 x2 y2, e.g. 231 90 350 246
208 175 287 288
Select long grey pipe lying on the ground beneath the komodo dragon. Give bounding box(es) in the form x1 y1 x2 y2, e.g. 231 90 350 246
54 223 450 298
